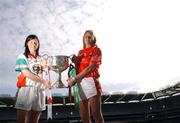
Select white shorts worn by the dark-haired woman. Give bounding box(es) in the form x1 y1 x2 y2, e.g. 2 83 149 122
15 87 46 111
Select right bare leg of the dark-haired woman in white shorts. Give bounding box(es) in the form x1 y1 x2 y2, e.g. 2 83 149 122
28 111 41 123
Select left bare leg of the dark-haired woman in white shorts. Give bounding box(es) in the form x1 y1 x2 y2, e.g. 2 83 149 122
17 109 30 123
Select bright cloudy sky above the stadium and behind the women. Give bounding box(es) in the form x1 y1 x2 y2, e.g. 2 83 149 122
0 0 180 95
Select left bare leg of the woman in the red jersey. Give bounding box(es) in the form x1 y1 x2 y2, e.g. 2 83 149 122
79 100 91 123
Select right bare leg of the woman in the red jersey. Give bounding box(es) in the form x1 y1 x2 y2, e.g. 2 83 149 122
89 94 104 123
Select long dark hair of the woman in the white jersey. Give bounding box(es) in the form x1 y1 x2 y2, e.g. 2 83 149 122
24 34 40 58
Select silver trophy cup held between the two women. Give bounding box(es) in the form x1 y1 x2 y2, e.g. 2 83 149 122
50 55 69 88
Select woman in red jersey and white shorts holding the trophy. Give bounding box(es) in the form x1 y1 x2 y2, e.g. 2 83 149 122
68 30 104 123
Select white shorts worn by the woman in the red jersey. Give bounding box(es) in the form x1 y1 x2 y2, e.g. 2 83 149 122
78 77 97 100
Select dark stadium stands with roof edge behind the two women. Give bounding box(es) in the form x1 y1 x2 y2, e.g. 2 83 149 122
0 83 180 123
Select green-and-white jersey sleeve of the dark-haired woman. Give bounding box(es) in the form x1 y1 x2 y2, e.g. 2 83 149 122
15 55 29 72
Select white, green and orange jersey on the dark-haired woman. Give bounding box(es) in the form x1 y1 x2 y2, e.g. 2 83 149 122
15 54 44 88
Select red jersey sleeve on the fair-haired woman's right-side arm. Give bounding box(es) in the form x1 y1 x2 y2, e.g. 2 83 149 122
90 48 102 66
